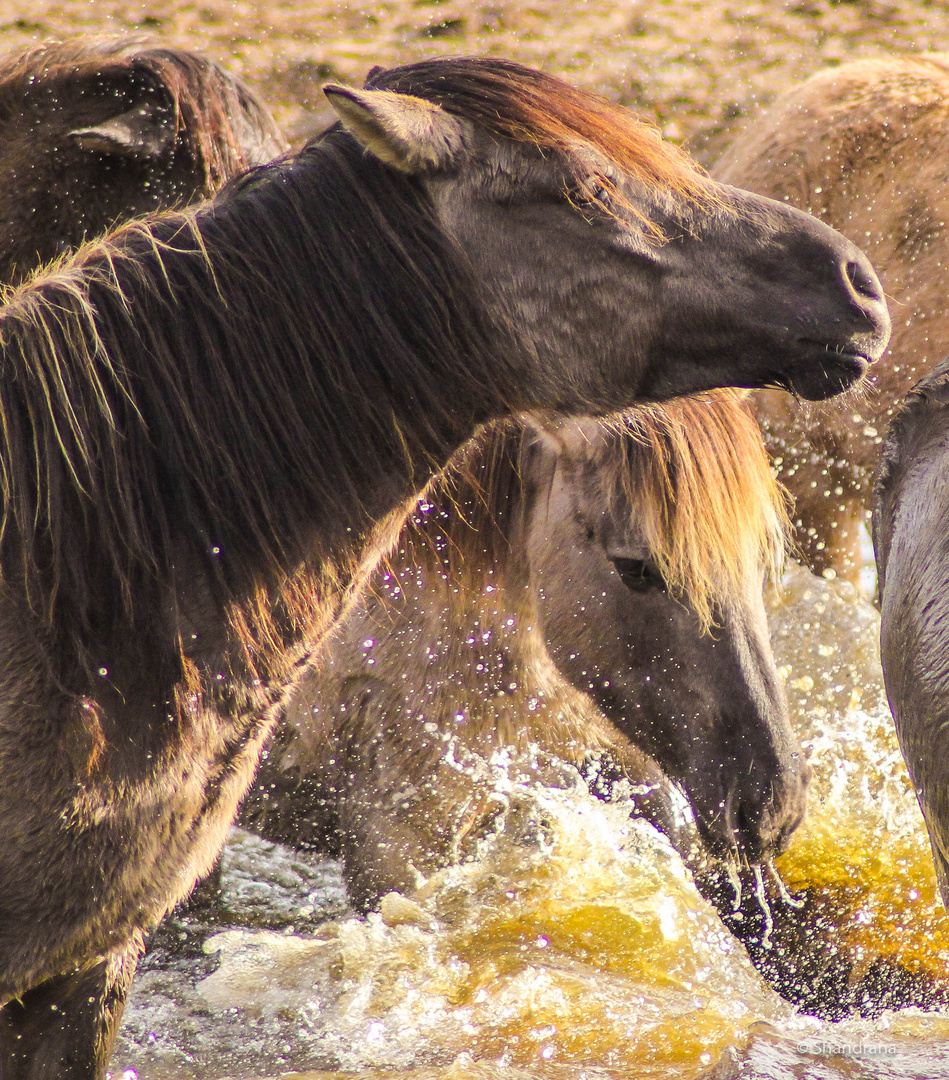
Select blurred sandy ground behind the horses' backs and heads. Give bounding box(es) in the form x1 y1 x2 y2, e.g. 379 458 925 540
0 0 949 164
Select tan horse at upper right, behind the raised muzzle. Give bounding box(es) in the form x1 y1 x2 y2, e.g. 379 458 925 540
713 55 949 583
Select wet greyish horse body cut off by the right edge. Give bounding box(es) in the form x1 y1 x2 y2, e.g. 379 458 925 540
873 361 949 906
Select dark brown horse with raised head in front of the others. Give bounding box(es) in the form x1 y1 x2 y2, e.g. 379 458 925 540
0 58 889 1080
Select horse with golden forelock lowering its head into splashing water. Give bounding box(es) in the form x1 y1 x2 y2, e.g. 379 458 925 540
242 392 804 909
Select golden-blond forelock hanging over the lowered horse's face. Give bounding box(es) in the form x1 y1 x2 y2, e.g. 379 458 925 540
591 390 789 629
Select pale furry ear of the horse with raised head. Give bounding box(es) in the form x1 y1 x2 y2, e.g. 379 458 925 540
323 83 466 173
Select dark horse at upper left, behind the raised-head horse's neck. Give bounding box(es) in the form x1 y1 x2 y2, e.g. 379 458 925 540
0 38 287 284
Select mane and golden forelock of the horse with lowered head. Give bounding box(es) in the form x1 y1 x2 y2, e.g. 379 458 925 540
404 390 789 631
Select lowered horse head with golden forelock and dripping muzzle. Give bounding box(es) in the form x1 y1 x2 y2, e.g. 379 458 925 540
527 395 808 862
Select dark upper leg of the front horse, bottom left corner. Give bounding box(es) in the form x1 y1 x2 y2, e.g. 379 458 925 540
0 949 138 1080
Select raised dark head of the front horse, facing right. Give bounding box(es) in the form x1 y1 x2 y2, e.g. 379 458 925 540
326 58 889 413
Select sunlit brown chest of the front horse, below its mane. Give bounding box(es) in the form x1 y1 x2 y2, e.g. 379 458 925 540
0 639 285 996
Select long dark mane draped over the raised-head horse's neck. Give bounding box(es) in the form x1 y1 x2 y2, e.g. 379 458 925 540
0 101 506 670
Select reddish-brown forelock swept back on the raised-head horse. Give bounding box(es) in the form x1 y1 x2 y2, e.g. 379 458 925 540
367 56 717 212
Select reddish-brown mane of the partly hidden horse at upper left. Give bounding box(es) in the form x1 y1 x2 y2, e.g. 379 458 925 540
0 36 286 198
